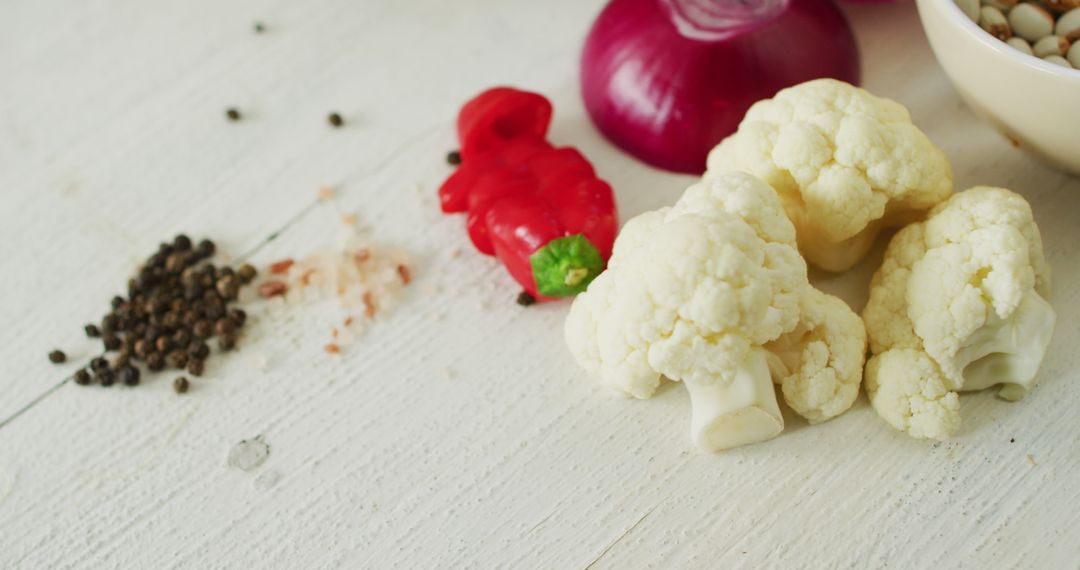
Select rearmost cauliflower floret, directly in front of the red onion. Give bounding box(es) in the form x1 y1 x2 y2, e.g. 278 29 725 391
705 79 953 271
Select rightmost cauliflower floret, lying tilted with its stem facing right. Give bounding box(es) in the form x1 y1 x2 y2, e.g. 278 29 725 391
863 187 1055 439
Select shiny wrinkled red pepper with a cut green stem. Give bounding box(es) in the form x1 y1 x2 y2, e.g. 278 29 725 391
438 87 619 299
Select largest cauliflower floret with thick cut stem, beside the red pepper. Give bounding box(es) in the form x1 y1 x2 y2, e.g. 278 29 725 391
566 173 866 450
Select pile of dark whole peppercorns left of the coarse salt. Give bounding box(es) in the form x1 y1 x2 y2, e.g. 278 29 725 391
49 234 256 393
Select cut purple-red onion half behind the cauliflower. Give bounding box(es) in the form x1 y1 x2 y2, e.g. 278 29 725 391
581 0 859 174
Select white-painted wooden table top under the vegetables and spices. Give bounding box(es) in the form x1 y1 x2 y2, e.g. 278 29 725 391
0 0 1080 569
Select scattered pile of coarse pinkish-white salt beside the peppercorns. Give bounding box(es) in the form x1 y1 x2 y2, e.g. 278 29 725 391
259 225 413 354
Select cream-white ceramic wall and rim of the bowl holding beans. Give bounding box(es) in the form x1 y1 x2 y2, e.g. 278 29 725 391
917 0 1080 174
